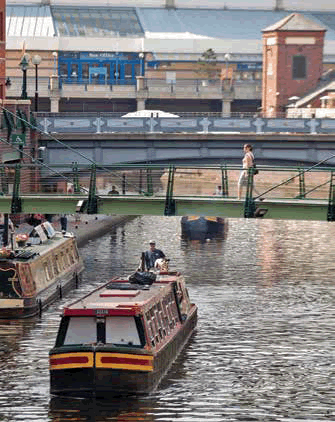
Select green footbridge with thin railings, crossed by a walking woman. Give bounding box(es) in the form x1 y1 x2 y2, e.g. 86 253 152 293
0 163 335 221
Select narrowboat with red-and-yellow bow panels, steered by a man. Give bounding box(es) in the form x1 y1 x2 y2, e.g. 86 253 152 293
49 262 197 397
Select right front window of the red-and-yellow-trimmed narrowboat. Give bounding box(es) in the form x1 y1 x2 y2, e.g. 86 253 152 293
106 316 141 346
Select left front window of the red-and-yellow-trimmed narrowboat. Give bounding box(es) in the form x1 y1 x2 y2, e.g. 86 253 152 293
64 317 97 345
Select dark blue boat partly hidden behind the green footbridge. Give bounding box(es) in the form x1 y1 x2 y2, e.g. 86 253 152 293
181 216 224 241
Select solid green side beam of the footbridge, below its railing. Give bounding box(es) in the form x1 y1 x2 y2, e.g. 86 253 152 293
0 195 328 221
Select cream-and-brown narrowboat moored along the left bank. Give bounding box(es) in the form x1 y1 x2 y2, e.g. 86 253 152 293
0 222 84 318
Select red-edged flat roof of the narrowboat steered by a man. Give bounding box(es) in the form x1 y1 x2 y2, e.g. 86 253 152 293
63 273 180 316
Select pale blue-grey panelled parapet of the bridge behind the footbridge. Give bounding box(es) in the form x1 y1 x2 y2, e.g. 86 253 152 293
37 110 328 134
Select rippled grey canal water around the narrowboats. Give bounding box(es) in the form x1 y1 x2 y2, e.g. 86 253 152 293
0 216 335 422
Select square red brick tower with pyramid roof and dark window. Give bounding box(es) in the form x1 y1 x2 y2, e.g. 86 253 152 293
262 13 326 116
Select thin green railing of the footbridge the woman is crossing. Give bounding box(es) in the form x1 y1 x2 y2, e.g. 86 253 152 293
0 162 335 200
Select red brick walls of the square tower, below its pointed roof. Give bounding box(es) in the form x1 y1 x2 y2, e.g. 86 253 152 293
262 31 324 115
